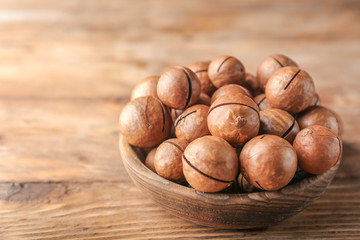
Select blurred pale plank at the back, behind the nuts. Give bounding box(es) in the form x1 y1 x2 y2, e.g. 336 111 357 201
0 0 360 98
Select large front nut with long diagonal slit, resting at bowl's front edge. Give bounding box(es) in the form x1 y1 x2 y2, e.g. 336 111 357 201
183 136 239 192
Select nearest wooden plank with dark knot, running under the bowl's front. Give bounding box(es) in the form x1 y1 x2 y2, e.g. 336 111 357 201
0 179 360 239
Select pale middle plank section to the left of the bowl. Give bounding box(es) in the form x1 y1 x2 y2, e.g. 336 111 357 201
0 99 128 182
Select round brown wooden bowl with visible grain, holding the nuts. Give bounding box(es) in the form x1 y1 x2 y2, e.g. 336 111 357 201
119 136 340 229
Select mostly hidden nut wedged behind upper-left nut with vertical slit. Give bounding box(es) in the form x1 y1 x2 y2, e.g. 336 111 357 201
187 61 216 95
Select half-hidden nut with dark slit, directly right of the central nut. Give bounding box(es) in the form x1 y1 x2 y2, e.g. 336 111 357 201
259 108 300 143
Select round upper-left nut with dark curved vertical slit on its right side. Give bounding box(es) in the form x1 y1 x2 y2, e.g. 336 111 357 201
157 66 201 109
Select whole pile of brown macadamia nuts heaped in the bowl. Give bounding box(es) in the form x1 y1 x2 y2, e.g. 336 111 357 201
119 54 342 193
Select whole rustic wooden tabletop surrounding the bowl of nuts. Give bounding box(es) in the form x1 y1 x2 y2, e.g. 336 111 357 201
0 0 360 240
